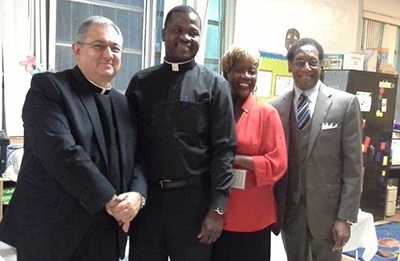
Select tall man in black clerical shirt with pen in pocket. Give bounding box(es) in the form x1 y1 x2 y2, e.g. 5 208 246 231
126 6 236 261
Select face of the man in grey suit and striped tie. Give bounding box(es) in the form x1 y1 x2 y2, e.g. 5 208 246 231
288 45 321 91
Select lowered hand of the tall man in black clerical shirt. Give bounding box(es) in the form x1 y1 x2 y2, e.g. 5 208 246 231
197 209 223 244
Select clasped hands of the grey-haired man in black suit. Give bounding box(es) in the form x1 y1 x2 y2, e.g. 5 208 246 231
106 192 141 233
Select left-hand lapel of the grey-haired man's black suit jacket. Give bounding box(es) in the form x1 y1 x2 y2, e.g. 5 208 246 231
72 66 108 167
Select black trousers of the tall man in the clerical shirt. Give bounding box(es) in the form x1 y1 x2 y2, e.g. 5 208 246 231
129 179 211 261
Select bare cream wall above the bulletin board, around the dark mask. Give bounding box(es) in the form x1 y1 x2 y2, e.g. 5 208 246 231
234 0 362 54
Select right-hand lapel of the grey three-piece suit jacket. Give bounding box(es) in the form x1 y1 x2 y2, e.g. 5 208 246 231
307 83 332 158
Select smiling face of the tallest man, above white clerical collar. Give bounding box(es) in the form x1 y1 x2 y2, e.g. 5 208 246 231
162 12 201 62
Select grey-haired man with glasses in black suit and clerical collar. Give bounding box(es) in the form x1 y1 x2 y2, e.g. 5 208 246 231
0 16 147 261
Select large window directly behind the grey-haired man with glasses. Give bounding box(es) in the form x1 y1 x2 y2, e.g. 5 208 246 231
54 0 144 91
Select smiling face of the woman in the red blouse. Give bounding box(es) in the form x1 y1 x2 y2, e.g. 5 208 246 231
225 56 258 104
